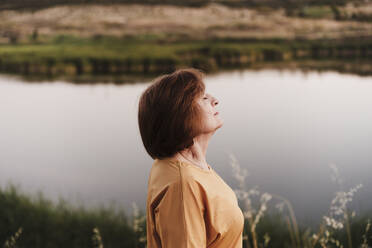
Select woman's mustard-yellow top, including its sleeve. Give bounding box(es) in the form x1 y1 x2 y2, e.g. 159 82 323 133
146 158 244 248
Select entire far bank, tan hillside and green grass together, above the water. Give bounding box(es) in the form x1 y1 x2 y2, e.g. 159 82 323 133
0 3 372 83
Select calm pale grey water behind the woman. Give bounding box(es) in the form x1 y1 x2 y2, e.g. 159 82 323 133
0 70 372 226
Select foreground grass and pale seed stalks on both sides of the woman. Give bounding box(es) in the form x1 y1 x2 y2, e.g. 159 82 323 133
0 154 372 248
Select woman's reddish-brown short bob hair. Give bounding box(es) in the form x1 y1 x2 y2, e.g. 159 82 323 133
138 68 205 159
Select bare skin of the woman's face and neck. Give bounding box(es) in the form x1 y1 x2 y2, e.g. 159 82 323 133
172 93 223 170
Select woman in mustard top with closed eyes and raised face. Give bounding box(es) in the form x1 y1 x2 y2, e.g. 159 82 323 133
138 68 244 248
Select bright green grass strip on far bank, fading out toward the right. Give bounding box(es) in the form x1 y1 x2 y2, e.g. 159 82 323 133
0 36 288 61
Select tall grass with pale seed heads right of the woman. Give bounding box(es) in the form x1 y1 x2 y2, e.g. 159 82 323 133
230 154 371 248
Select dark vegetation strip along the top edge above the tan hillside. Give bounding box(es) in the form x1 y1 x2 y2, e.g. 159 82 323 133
0 0 372 22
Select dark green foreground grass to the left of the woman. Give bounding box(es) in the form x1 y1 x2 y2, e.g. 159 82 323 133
0 182 137 248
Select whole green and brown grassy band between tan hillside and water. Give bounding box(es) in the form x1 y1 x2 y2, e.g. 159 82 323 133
0 35 372 82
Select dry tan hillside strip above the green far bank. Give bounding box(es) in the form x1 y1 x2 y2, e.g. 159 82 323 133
0 4 372 39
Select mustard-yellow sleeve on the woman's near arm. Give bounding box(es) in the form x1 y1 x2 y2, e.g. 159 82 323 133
154 178 207 248
